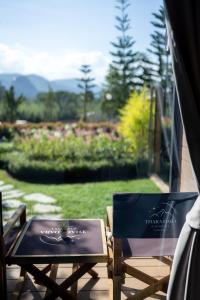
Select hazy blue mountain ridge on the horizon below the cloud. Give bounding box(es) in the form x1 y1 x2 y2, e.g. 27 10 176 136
0 73 100 99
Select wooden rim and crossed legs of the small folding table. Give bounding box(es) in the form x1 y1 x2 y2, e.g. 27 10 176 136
9 219 107 300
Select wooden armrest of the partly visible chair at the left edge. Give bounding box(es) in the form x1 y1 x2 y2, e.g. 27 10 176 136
3 204 26 239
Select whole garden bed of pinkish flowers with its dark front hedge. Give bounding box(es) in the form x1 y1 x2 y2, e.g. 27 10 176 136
0 123 144 182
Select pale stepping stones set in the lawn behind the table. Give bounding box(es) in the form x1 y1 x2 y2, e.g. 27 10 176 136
0 180 62 221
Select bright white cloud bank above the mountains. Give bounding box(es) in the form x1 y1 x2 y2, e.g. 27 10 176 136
0 43 109 82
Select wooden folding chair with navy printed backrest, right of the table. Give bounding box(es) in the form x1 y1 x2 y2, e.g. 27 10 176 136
107 193 197 300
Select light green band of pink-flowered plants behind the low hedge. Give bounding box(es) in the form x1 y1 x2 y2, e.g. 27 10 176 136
14 133 131 162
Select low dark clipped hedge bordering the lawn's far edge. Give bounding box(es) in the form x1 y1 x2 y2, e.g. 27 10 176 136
0 153 147 183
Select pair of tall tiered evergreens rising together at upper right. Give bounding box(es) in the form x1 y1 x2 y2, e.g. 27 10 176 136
102 0 173 118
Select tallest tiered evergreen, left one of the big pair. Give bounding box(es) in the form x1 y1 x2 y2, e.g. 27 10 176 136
106 0 137 114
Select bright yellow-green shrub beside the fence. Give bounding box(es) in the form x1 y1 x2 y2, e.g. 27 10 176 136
119 88 150 160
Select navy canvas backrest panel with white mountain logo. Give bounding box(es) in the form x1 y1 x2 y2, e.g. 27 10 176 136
113 192 198 238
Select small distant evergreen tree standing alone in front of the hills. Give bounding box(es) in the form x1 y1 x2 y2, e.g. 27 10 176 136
78 65 95 122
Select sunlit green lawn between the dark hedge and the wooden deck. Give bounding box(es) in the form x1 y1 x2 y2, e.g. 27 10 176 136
0 170 160 218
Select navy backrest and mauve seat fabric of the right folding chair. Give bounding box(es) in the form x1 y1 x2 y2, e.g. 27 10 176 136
112 192 198 256
